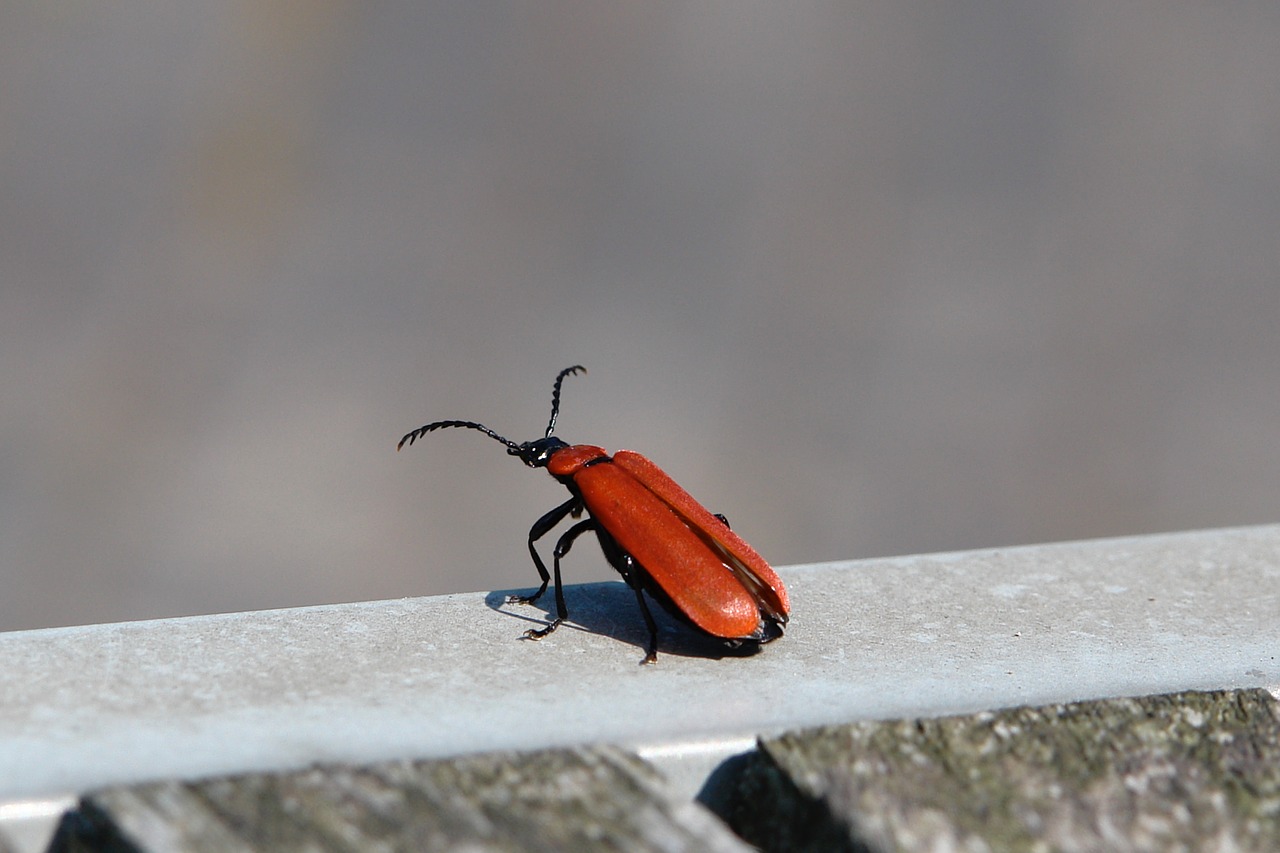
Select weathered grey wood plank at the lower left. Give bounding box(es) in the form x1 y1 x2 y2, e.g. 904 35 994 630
51 747 749 853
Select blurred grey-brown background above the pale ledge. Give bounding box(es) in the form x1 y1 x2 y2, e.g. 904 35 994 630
0 0 1280 630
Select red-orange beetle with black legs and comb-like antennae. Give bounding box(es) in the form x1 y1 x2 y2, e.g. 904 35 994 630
396 365 791 663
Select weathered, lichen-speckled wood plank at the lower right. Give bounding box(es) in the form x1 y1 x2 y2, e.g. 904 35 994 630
727 690 1280 852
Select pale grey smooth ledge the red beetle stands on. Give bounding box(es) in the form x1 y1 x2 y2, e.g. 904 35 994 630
0 525 1280 840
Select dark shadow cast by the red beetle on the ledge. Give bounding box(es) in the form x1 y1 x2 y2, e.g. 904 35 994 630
485 580 760 661
